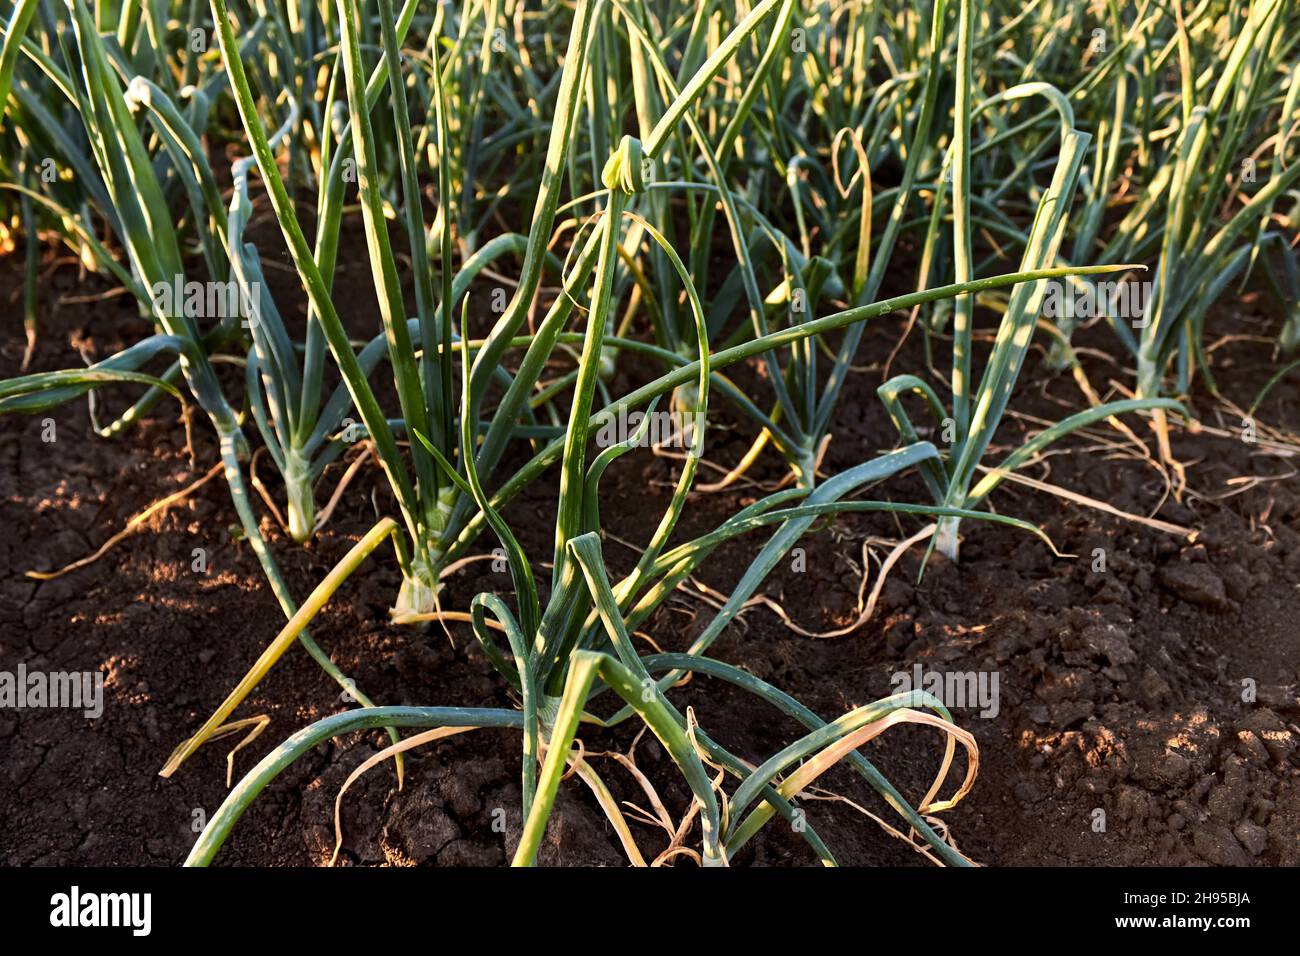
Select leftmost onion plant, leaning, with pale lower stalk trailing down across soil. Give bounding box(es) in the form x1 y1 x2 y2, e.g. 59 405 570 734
0 0 403 738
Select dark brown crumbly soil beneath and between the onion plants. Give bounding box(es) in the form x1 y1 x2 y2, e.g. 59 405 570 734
0 235 1300 866
